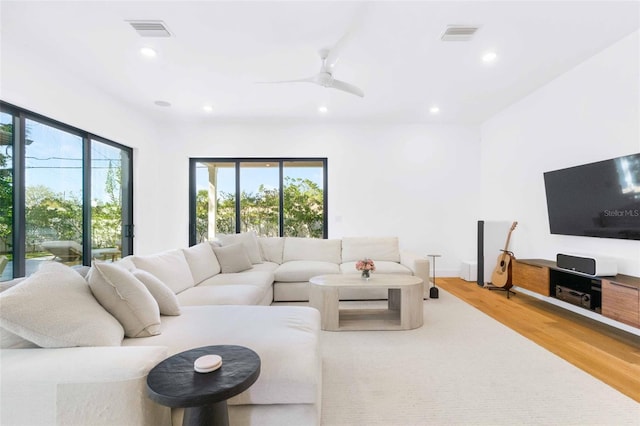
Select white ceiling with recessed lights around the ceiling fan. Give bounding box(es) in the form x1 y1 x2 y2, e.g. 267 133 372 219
0 0 640 123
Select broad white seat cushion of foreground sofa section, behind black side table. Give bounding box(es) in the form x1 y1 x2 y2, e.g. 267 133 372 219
122 305 322 405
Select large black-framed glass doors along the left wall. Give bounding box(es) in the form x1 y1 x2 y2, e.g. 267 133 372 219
0 103 133 280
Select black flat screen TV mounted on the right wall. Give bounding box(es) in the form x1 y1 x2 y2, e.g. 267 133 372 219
544 153 640 240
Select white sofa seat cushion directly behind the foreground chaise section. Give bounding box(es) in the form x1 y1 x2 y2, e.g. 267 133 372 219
177 284 264 306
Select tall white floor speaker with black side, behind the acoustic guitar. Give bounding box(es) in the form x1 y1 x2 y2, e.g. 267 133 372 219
476 220 513 287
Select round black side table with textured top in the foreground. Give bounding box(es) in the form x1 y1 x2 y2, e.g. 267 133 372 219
147 345 260 426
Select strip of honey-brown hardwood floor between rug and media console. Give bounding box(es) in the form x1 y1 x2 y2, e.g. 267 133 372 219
434 278 640 402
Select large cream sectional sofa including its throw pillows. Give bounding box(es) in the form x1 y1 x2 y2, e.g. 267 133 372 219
0 233 429 425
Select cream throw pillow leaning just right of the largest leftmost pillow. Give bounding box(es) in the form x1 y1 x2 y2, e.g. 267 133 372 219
88 262 160 337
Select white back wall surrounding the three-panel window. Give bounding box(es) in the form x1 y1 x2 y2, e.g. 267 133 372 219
149 124 480 275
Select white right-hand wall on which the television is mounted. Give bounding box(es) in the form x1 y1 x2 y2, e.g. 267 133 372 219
481 31 640 276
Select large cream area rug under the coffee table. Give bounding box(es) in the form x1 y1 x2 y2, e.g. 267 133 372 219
312 289 640 426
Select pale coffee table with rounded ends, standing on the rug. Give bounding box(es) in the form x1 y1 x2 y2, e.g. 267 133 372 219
309 274 424 331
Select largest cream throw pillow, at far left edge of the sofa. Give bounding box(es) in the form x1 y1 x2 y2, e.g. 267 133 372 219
0 262 124 348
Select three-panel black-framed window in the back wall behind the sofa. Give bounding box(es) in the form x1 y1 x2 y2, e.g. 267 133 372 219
189 158 327 245
